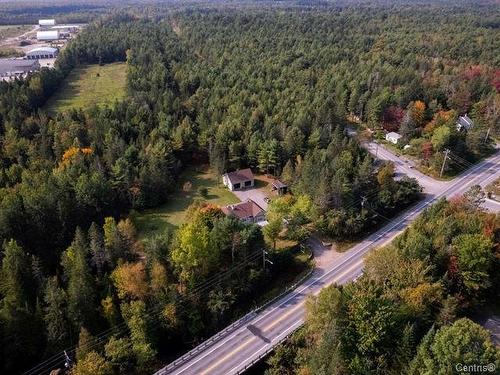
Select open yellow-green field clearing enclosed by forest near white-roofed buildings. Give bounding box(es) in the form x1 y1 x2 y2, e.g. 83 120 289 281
45 63 127 114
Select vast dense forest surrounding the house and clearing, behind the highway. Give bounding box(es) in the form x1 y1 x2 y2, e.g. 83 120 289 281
0 1 500 374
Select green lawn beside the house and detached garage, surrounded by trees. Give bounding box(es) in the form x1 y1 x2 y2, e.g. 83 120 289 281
132 169 239 240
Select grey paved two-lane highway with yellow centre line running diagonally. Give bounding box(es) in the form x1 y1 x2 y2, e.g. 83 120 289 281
156 152 500 375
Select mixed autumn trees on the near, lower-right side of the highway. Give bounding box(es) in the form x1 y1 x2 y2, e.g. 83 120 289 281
266 197 500 375
